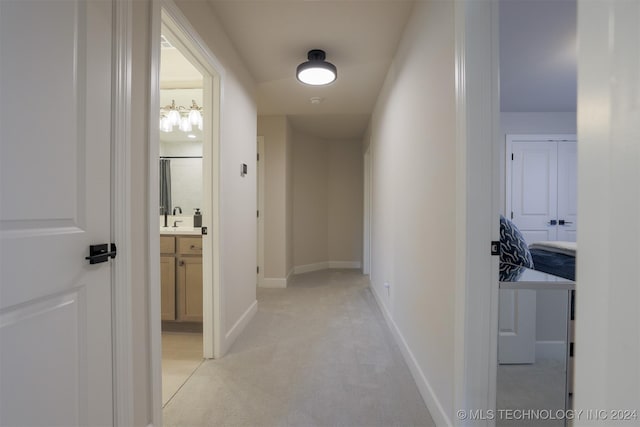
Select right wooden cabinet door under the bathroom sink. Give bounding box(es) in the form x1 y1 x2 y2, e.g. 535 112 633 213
177 257 202 322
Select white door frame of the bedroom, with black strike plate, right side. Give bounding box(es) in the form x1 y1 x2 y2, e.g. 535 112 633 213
450 0 502 425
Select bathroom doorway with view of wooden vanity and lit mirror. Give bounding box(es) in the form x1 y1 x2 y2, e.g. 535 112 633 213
149 3 221 417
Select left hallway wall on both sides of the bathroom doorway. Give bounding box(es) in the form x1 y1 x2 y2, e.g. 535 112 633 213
131 0 257 426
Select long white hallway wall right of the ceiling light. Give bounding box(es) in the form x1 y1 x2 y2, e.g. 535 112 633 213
370 1 456 425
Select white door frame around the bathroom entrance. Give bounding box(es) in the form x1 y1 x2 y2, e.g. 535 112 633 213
147 0 225 425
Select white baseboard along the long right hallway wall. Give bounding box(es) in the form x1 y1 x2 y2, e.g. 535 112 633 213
369 283 453 426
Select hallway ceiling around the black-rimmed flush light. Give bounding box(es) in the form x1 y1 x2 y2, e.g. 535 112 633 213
209 0 414 139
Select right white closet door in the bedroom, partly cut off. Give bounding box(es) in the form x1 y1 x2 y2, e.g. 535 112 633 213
557 141 578 242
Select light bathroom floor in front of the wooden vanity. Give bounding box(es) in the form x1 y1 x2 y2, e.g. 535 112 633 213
162 332 202 406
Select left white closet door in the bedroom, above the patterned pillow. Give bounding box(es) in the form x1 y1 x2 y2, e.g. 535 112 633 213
507 141 558 244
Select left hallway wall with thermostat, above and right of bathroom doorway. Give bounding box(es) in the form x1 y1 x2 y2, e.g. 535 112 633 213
176 0 257 353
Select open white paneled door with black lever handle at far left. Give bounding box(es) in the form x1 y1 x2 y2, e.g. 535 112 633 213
0 0 113 426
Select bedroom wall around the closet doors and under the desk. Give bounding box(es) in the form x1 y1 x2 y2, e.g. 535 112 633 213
499 112 577 357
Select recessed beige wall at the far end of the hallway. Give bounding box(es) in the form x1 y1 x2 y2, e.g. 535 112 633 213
293 132 363 268
